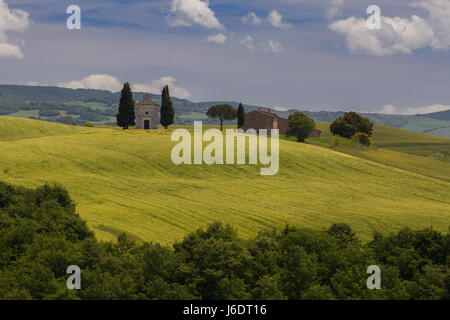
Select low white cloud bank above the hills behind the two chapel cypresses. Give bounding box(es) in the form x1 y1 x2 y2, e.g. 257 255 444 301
57 74 192 99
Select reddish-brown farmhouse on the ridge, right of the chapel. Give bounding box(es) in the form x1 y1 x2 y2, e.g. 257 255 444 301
243 108 322 138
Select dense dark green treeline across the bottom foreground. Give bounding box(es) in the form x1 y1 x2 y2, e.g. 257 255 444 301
0 183 450 299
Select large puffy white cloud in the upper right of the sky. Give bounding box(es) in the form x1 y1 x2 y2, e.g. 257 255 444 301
329 15 434 56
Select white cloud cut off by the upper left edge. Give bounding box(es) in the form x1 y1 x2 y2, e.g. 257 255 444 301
0 0 30 59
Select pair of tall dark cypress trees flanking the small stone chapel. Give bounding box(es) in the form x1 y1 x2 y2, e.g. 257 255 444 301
116 82 175 130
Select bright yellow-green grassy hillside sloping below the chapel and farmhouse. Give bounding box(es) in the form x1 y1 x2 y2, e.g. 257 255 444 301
0 117 450 244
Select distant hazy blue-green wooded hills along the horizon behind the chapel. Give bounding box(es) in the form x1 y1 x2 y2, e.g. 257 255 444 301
0 85 450 138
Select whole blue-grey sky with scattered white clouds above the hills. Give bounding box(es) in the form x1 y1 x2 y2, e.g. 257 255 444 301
0 0 450 114
